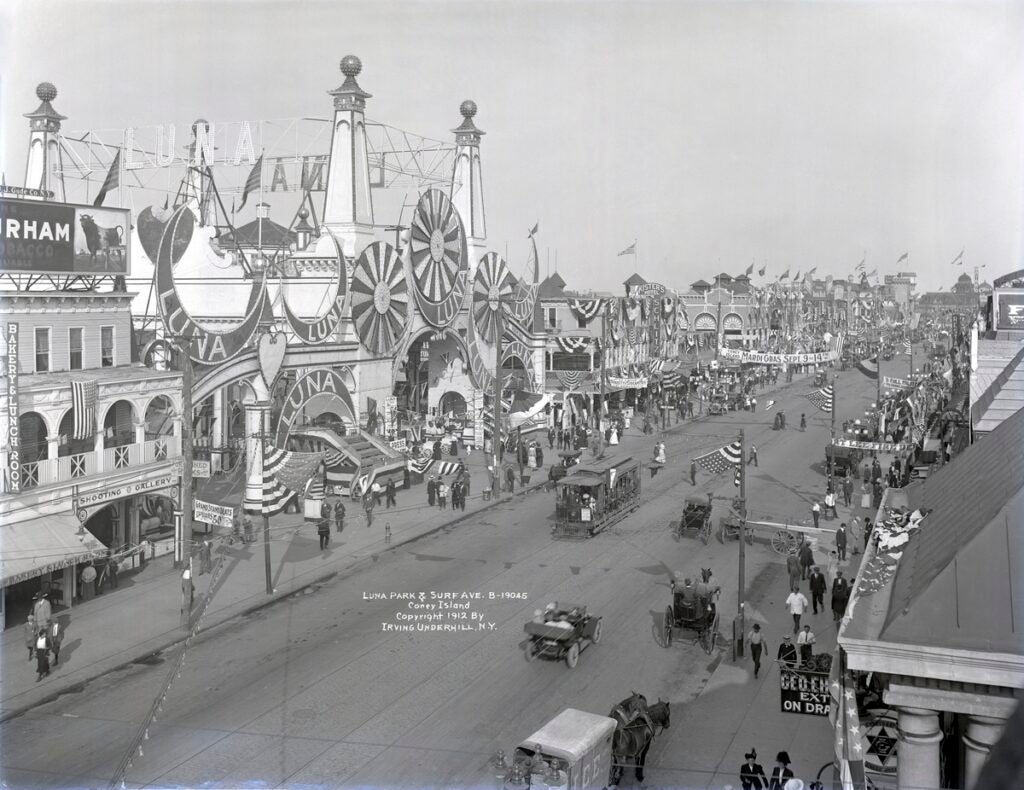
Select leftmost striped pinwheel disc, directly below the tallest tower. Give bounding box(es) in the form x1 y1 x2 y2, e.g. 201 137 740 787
351 242 409 355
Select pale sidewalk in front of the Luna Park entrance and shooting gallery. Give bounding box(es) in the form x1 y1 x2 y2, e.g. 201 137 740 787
0 448 550 720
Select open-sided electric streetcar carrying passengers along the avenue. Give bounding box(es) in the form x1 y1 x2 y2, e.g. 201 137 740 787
551 456 641 538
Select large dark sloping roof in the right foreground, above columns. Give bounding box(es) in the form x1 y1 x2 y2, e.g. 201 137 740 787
880 411 1024 655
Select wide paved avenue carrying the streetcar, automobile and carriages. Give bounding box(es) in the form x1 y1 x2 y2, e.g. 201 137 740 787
0 360 892 787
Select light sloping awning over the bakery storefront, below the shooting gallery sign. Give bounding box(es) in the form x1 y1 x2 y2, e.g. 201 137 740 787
0 513 106 587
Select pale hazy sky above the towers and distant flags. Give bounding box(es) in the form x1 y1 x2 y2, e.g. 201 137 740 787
0 0 1024 292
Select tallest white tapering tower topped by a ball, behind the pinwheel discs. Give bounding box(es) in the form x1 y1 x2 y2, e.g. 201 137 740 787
324 55 376 257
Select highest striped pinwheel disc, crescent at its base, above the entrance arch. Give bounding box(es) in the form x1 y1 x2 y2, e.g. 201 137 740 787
410 190 469 329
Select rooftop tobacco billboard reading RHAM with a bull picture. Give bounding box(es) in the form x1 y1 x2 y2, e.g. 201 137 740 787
0 197 131 276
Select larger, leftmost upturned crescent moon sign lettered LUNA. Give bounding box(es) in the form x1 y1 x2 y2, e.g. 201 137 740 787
156 206 272 365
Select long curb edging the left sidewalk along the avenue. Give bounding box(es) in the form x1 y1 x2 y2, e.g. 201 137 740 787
0 475 544 723
